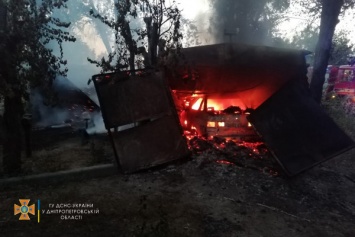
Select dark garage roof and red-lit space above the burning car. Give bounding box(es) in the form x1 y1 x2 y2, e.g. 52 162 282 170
167 44 309 108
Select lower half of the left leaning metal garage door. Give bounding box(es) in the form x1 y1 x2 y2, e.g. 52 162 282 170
112 116 189 173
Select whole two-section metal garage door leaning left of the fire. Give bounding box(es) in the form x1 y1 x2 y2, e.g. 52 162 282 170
93 72 189 173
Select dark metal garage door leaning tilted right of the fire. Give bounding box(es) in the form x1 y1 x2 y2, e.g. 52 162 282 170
248 80 354 176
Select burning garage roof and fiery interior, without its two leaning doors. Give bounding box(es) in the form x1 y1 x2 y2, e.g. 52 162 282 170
168 44 307 139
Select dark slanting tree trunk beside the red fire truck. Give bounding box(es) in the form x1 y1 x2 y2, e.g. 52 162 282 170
310 0 344 103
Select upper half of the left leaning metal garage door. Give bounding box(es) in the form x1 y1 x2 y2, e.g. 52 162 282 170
93 73 172 129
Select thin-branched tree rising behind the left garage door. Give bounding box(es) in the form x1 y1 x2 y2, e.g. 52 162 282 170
88 0 182 73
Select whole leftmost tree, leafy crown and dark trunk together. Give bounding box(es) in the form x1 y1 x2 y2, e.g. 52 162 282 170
0 0 75 175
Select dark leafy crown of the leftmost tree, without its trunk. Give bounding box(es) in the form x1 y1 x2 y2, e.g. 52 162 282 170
0 0 75 101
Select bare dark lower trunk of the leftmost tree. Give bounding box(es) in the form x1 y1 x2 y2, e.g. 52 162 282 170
3 93 23 175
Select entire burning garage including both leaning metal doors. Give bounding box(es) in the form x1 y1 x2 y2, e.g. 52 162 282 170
93 44 354 176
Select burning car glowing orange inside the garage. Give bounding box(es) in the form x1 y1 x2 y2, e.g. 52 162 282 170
173 94 257 138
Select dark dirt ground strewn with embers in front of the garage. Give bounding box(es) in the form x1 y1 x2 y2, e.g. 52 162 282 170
0 99 355 237
